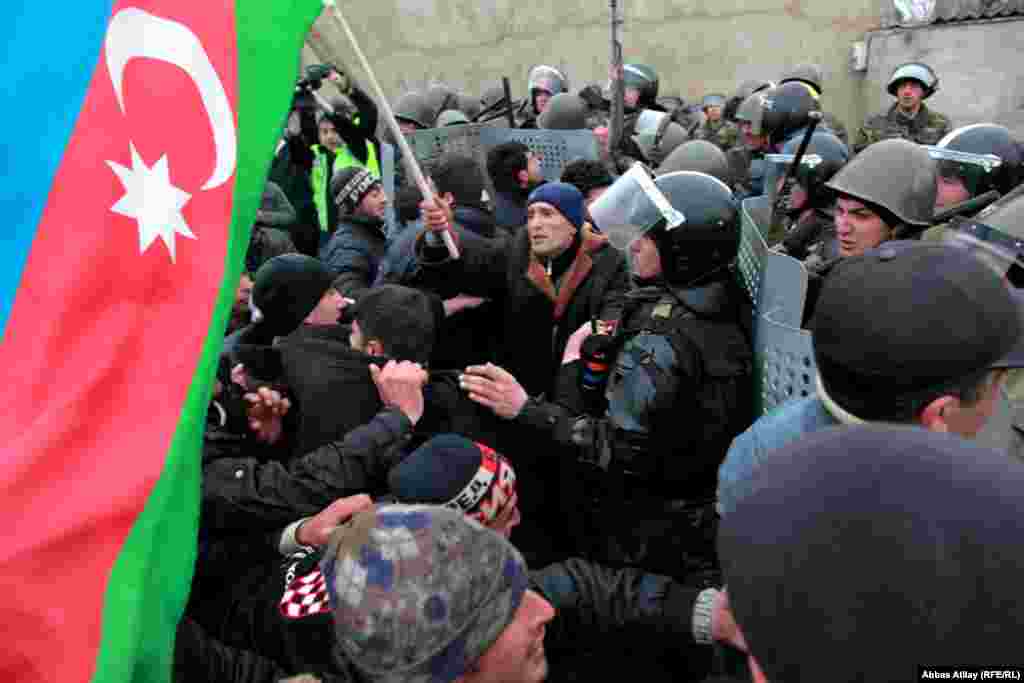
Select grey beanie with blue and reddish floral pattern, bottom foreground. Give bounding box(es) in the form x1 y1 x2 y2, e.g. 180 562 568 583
321 505 527 683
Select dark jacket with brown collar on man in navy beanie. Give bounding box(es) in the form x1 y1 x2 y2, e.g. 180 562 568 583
418 226 629 395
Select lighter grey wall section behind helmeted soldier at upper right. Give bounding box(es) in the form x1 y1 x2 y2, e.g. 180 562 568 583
864 18 1024 137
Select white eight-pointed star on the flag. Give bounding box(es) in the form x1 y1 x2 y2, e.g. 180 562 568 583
106 142 196 263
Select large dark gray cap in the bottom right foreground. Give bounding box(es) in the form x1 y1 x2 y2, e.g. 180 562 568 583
719 426 1024 683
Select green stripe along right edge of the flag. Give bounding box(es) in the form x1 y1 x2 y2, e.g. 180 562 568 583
95 0 322 683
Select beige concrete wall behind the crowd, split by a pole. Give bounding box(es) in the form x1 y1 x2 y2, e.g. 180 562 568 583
305 0 880 137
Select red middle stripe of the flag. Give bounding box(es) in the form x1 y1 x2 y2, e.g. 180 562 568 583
0 0 239 681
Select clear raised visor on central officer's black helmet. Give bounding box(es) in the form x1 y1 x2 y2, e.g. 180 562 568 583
590 163 686 250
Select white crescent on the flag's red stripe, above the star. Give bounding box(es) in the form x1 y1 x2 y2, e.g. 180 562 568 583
103 7 238 189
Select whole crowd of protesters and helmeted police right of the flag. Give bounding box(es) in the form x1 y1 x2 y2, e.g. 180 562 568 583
175 57 1024 683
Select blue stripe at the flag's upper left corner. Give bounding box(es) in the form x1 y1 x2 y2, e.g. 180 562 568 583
0 0 113 339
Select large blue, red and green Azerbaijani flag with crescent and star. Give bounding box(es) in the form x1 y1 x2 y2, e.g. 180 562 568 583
0 0 321 683
